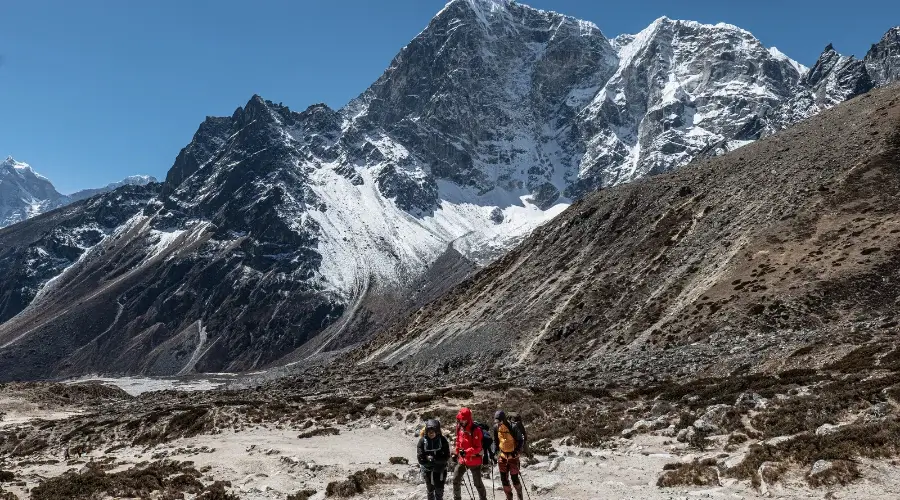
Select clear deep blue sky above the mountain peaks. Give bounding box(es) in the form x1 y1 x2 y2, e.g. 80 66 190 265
0 0 900 193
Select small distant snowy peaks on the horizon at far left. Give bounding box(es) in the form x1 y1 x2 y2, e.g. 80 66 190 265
0 157 156 228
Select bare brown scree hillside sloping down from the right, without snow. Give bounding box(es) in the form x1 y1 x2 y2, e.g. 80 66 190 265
358 85 900 379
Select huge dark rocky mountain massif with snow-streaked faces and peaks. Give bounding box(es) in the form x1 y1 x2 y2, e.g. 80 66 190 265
0 0 894 378
